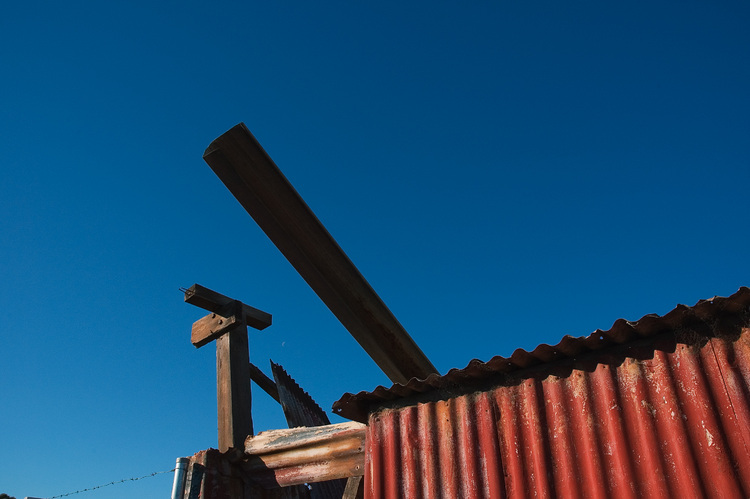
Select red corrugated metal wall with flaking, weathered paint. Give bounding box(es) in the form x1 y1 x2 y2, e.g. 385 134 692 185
365 329 750 498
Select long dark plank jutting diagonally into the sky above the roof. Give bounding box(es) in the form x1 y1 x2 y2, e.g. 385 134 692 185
203 123 437 384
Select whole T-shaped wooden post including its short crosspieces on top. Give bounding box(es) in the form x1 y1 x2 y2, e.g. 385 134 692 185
185 284 271 452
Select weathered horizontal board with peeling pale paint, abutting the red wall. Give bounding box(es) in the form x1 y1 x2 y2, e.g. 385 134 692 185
243 422 365 488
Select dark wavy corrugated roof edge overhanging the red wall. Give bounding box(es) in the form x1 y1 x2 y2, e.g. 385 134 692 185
333 286 750 422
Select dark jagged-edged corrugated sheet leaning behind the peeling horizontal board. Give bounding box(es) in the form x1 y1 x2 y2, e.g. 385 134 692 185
271 361 346 499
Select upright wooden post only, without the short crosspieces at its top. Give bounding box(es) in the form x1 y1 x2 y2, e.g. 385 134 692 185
216 321 253 452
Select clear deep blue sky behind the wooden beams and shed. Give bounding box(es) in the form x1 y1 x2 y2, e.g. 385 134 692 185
0 0 750 499
